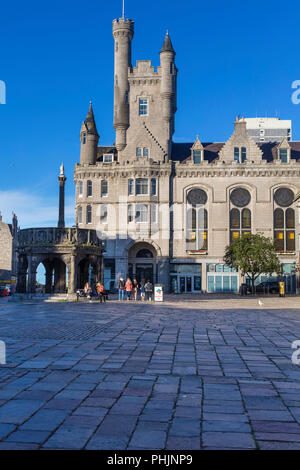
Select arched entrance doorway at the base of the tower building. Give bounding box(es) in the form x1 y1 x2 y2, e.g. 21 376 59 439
128 242 157 283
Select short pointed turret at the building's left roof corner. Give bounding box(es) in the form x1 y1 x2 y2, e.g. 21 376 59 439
80 102 99 165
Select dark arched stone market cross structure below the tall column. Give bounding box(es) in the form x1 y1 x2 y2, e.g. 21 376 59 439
17 228 103 294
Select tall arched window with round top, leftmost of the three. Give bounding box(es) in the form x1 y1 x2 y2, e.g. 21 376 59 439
186 188 208 251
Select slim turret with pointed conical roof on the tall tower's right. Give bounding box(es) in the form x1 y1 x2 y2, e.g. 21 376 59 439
159 32 177 129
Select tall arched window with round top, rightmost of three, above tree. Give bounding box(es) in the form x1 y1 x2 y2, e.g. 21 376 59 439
274 188 296 252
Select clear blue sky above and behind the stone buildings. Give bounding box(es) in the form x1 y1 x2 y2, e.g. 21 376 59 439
0 0 300 227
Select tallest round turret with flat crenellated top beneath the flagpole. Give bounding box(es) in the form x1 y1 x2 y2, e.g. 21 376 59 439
113 17 134 150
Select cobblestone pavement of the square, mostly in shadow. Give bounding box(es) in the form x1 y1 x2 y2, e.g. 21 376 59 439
0 297 300 450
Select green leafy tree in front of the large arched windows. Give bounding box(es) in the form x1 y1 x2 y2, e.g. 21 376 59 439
224 234 281 293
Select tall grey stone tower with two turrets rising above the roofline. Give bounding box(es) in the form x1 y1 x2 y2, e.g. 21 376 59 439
113 18 177 162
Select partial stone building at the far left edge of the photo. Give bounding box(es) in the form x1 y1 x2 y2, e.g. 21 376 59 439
0 215 18 281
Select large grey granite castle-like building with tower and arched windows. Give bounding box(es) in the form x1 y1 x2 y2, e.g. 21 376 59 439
74 13 300 292
